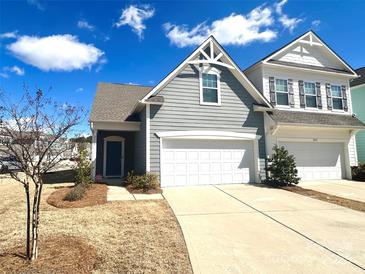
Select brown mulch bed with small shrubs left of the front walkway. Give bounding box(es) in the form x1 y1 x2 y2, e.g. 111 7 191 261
47 184 108 208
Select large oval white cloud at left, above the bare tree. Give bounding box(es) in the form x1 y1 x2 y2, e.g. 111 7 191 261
7 34 104 71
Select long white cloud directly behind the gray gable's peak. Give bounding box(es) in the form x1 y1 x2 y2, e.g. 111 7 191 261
164 6 277 47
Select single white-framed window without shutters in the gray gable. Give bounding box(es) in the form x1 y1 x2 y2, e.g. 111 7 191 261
200 72 221 105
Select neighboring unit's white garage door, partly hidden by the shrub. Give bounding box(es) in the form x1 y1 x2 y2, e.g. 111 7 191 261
281 142 345 180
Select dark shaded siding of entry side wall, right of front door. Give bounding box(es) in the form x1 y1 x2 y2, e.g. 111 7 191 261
134 108 146 173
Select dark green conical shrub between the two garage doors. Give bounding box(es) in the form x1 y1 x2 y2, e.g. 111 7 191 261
266 145 300 186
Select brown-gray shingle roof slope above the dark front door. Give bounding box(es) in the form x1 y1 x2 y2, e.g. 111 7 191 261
90 83 152 122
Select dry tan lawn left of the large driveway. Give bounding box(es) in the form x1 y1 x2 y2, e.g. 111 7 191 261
0 179 192 273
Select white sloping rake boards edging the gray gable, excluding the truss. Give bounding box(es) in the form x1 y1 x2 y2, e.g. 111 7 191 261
141 36 272 108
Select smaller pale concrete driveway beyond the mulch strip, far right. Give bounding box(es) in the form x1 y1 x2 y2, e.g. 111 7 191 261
300 180 365 203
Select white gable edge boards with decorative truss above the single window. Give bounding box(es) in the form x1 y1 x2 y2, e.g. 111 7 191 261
141 36 272 108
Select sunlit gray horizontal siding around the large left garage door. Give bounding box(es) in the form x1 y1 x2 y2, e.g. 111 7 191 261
150 66 266 180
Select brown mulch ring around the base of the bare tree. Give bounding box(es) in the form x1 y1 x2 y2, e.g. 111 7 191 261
0 236 100 274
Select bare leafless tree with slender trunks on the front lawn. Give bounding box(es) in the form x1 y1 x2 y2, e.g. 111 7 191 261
0 88 84 261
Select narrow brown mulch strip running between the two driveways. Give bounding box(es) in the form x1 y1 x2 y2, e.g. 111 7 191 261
282 186 365 212
